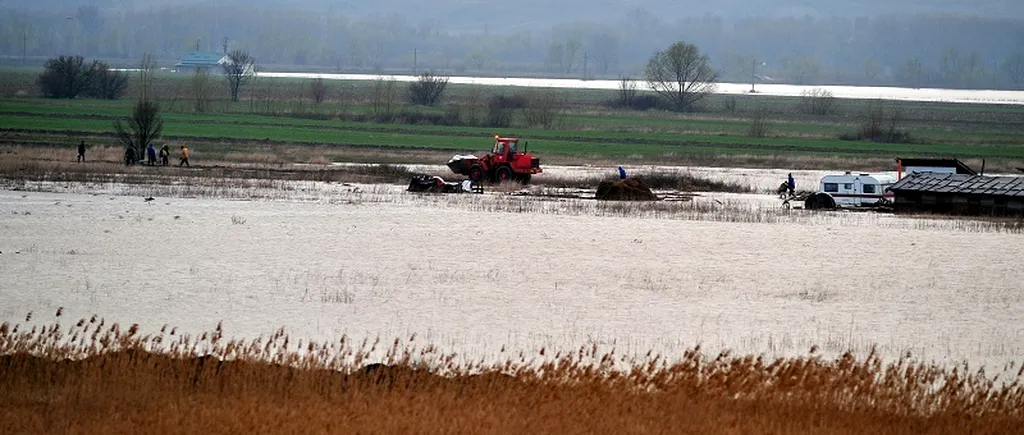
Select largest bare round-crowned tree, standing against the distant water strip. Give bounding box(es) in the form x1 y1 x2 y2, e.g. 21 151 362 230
645 42 718 112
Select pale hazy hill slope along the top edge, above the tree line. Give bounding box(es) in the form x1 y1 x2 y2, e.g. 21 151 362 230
8 0 1024 23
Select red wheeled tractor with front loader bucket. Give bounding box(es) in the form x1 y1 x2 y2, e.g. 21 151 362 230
447 135 544 184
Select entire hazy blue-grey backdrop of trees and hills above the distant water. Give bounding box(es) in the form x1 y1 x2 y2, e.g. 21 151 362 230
0 0 1024 89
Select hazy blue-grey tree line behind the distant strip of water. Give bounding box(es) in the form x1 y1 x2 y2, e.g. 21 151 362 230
0 3 1024 88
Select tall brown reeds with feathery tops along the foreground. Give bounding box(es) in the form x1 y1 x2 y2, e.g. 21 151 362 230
0 311 1024 434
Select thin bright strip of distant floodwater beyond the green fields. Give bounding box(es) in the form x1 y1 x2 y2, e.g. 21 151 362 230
259 72 1024 104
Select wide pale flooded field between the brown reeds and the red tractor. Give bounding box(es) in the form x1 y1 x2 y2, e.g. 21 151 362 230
0 175 1024 369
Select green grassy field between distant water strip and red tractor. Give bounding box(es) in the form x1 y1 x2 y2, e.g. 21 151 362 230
6 70 1024 171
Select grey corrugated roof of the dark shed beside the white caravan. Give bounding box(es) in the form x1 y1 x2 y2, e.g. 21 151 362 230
889 172 1024 197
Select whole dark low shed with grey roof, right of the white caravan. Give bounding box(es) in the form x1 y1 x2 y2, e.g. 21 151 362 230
889 172 1024 216
